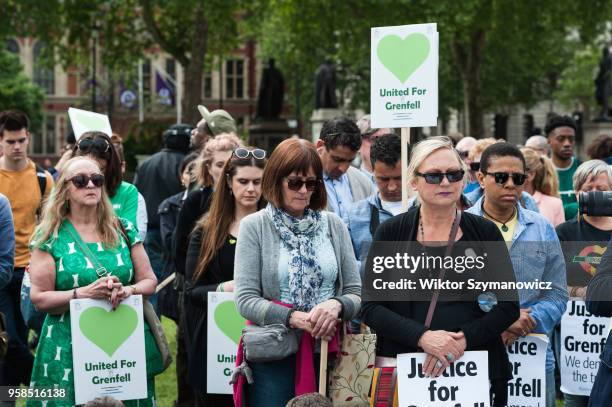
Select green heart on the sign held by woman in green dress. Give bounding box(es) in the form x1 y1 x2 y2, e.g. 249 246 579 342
79 304 138 357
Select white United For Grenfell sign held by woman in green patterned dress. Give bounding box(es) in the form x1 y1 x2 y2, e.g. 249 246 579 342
70 295 147 404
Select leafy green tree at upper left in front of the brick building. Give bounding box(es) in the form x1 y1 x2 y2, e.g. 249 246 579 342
0 0 239 122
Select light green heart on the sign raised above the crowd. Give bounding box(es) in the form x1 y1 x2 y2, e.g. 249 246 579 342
376 33 430 83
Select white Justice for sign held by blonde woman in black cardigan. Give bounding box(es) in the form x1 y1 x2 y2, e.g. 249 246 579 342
397 351 489 407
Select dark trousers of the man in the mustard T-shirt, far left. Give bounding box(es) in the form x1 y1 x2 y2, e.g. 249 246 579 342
0 268 34 386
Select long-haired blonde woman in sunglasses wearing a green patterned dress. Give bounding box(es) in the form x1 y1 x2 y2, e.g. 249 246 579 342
27 157 162 406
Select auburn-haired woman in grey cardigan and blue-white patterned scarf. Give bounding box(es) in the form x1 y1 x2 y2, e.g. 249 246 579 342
234 139 361 406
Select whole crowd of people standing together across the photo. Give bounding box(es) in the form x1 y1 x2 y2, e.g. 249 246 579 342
0 106 612 406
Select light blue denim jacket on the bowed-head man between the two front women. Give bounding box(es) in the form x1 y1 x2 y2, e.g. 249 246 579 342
348 192 393 270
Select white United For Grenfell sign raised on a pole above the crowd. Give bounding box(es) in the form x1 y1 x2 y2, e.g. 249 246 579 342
370 23 439 128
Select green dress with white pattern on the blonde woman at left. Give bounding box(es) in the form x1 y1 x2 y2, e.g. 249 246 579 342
27 219 161 407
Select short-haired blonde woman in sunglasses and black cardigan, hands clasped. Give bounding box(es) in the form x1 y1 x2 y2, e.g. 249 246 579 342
362 137 519 406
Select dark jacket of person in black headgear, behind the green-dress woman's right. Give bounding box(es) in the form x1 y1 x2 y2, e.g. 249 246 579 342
134 148 185 229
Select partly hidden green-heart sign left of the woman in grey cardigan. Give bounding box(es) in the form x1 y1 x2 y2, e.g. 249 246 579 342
206 292 246 394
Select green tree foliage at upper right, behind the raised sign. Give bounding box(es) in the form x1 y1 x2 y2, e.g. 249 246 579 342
251 0 612 136
